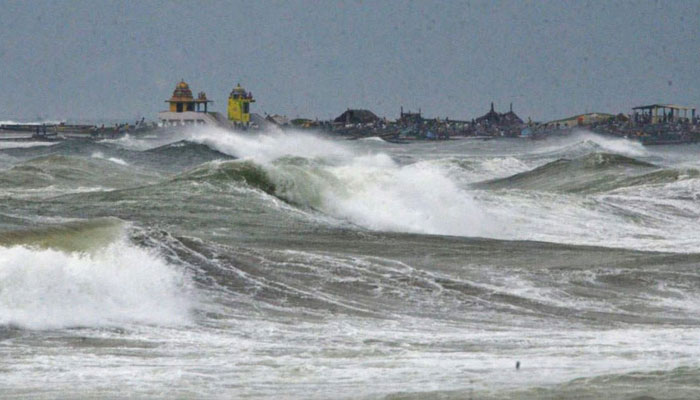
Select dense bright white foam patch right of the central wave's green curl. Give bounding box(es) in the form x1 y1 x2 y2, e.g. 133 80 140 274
323 154 487 236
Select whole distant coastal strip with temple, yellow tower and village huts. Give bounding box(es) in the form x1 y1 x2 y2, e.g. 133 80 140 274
0 80 700 145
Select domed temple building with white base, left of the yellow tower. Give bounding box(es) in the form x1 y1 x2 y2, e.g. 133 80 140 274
158 80 225 126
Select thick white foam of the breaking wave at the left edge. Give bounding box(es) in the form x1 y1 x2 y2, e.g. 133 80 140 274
0 239 191 329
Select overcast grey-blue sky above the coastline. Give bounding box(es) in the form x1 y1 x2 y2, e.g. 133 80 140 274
0 0 700 120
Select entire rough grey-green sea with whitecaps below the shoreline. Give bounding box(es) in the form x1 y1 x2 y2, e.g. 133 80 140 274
0 129 700 399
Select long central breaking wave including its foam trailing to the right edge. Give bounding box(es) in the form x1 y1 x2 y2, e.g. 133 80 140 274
168 126 698 252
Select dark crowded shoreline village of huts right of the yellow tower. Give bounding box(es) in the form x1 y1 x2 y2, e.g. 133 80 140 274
310 103 700 144
